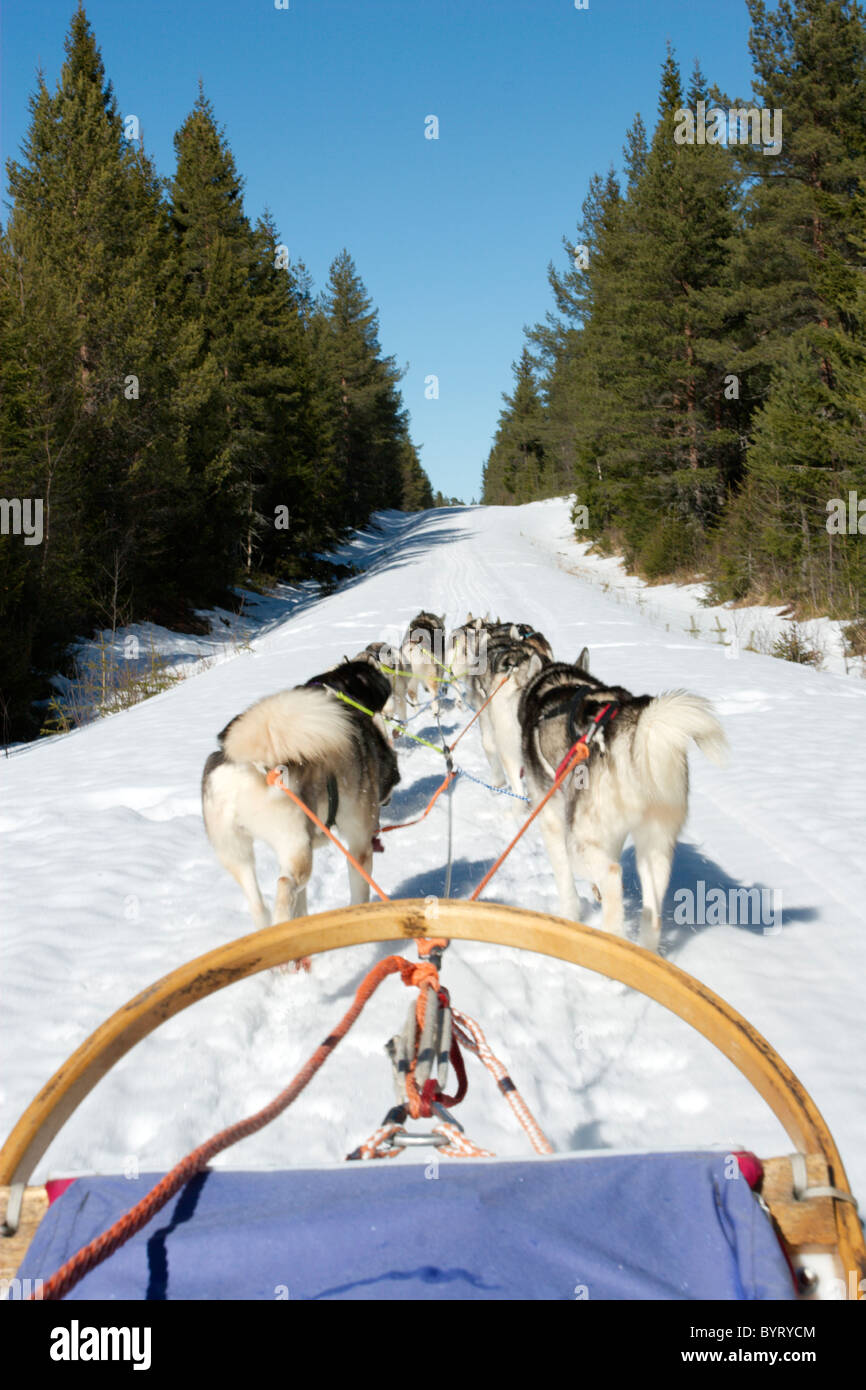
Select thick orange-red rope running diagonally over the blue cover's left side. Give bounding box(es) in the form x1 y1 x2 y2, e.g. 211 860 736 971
40 956 439 1300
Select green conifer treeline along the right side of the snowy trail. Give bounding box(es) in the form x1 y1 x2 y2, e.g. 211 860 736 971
484 0 866 620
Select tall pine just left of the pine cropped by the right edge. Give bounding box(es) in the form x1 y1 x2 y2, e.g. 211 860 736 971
602 51 734 575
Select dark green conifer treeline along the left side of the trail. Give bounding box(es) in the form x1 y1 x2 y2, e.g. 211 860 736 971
0 7 432 738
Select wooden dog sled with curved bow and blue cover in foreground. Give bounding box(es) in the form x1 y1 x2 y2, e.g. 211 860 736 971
0 899 866 1301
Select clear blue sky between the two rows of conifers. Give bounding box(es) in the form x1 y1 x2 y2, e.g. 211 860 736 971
0 0 751 502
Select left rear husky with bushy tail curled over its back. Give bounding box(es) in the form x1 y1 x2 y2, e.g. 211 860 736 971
202 662 400 927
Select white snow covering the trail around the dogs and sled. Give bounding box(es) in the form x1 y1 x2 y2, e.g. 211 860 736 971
0 500 866 1200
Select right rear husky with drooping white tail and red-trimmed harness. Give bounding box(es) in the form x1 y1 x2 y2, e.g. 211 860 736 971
518 648 727 951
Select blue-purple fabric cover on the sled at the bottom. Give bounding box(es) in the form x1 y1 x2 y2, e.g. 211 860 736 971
19 1152 794 1301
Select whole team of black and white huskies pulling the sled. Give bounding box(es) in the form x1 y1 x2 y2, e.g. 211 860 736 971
202 613 727 949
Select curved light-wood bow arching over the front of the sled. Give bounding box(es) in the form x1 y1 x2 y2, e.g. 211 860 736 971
0 899 866 1276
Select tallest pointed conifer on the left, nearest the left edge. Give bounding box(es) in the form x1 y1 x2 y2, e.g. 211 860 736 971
0 6 178 719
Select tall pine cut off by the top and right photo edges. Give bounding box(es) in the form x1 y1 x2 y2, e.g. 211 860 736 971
717 0 866 612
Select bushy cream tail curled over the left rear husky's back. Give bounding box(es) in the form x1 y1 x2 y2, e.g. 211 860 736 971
222 685 352 767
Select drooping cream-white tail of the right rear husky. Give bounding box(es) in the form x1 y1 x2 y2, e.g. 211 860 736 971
634 691 728 801
